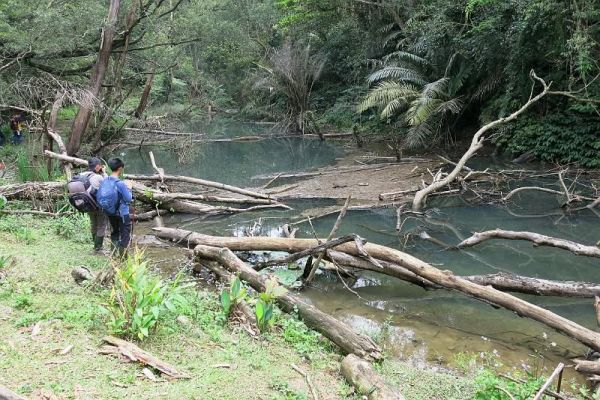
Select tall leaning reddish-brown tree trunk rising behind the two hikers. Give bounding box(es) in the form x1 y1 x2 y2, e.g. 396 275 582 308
67 0 121 155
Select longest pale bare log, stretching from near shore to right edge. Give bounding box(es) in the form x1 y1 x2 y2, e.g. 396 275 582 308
154 228 600 350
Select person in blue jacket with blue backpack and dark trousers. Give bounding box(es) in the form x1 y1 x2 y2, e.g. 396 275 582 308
96 158 133 257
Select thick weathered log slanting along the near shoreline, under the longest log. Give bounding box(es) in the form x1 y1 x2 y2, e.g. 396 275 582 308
194 245 383 361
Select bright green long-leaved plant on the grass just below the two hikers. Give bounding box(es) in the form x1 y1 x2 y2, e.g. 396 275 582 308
101 252 185 340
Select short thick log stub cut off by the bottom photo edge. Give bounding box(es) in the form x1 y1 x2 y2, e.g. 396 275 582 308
341 354 404 400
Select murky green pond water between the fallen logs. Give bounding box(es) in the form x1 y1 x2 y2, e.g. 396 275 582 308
125 120 600 374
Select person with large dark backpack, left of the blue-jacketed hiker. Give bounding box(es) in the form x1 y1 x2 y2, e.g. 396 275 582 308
67 157 108 254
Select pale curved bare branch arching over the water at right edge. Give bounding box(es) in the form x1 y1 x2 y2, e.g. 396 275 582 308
456 229 600 257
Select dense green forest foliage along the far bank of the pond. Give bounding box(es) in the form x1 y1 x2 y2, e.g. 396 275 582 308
0 0 600 163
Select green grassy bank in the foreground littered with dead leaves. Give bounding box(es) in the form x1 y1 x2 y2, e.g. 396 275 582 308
0 216 482 399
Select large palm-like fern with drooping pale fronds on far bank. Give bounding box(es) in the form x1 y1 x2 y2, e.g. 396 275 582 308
358 51 465 147
